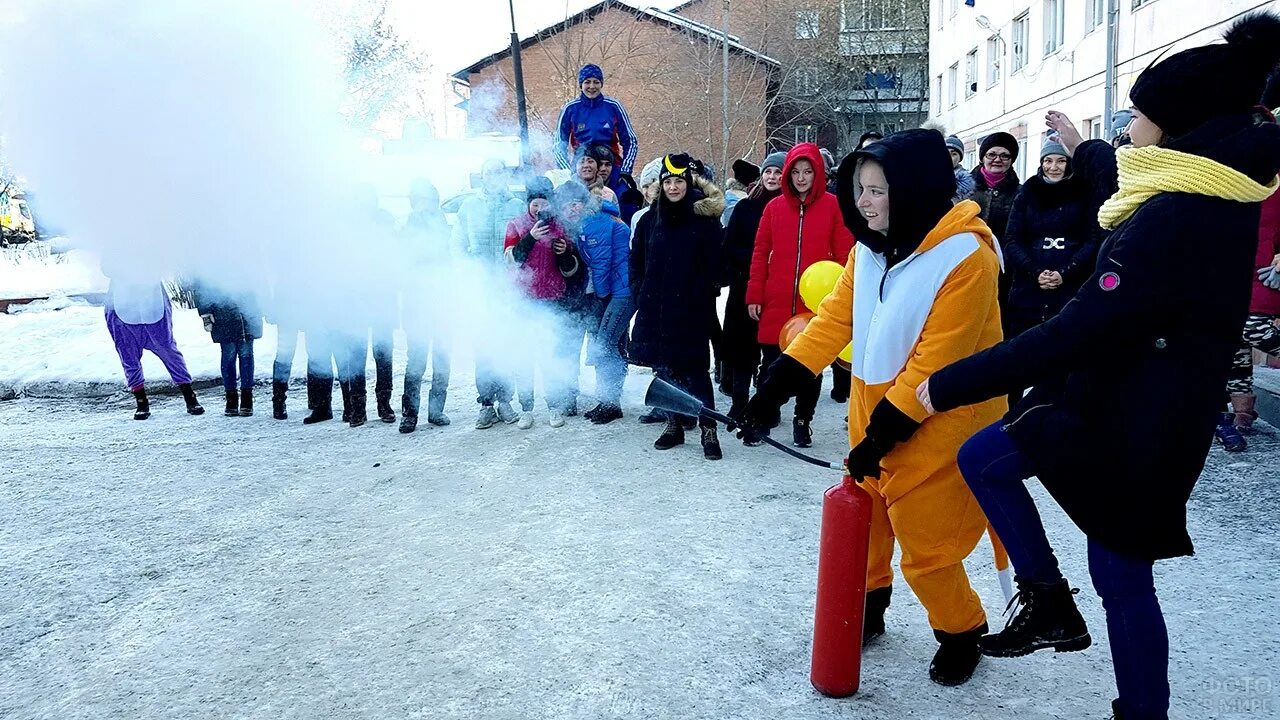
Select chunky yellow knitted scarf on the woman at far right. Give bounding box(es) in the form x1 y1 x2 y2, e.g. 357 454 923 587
1098 146 1280 229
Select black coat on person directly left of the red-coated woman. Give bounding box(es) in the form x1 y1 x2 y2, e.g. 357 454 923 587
722 191 782 357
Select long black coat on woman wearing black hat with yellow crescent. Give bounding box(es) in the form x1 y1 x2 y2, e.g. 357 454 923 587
627 195 737 372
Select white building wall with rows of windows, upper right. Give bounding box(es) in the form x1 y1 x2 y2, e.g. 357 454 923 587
929 0 1280 177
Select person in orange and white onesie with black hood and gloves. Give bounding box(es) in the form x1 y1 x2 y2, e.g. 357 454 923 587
741 129 1006 685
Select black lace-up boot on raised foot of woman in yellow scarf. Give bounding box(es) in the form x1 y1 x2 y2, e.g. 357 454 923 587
978 577 1093 657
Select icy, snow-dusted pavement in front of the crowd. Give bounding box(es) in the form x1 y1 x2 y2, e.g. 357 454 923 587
0 379 1280 720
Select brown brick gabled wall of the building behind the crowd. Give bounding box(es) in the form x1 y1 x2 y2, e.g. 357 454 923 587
467 8 769 173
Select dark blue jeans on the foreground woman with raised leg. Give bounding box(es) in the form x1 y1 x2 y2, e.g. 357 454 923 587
957 423 1169 720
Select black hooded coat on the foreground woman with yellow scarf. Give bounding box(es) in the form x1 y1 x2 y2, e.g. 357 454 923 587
929 113 1280 560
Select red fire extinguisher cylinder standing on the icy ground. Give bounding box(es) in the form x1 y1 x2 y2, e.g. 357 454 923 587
809 475 872 697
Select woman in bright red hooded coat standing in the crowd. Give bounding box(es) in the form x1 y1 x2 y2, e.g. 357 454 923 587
746 142 854 447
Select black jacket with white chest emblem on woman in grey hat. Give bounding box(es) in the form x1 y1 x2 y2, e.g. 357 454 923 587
1001 174 1102 325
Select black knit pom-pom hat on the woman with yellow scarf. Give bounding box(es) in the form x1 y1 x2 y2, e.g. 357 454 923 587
1129 12 1280 137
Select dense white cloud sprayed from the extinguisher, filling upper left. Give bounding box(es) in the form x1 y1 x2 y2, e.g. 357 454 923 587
0 0 565 386
